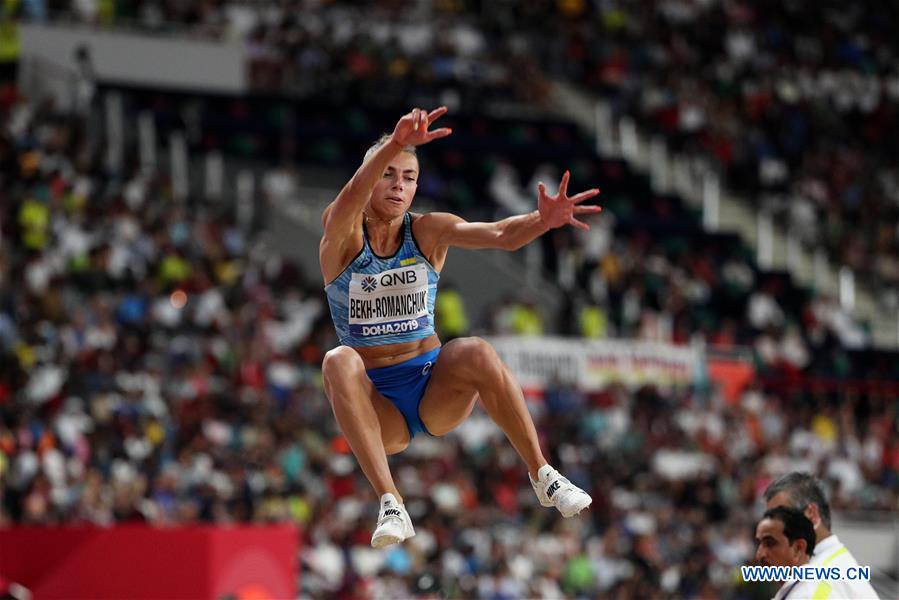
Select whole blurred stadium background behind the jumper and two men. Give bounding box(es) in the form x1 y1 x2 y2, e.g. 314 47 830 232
0 0 899 599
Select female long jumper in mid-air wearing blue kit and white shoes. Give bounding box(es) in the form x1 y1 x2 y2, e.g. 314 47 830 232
319 107 601 548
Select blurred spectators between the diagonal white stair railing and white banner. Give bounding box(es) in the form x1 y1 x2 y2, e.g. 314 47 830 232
487 154 884 378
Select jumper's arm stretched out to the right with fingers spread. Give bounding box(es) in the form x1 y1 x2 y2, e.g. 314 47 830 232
423 171 602 250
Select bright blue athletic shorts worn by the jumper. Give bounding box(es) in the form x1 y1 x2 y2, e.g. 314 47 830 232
365 346 440 439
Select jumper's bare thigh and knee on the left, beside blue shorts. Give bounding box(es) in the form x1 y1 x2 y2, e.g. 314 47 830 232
323 346 409 454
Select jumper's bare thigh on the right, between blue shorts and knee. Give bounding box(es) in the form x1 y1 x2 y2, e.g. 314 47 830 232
418 338 478 435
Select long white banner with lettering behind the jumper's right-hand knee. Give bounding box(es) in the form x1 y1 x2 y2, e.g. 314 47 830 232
487 336 703 391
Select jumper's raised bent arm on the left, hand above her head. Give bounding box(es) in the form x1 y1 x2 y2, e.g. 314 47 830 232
322 106 452 240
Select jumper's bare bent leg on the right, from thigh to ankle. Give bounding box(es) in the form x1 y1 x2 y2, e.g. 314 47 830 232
419 337 546 479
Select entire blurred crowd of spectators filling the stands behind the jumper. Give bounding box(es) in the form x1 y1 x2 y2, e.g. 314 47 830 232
0 0 899 599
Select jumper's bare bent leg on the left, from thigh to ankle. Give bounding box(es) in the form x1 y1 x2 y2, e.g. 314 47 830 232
322 346 409 503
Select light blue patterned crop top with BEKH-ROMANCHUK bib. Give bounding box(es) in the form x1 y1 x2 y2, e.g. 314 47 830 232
325 213 440 347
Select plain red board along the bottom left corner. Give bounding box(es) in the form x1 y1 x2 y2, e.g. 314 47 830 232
0 525 299 600
